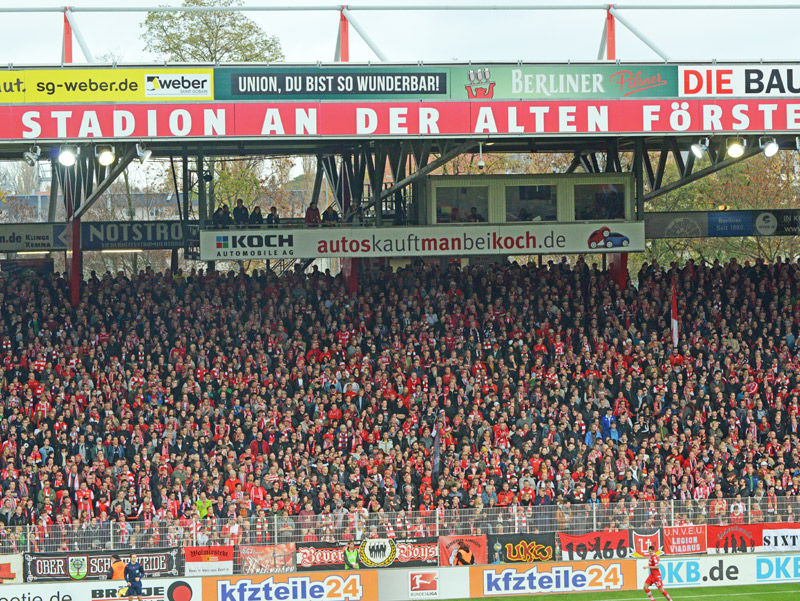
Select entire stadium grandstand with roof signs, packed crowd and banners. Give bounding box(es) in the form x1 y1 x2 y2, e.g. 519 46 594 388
0 0 800 601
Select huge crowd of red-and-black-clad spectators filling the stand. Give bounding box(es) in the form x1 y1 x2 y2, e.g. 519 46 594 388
0 254 800 551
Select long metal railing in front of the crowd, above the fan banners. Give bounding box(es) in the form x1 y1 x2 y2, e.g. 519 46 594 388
0 495 800 554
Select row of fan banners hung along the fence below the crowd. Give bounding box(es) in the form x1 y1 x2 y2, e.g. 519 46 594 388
7 522 800 582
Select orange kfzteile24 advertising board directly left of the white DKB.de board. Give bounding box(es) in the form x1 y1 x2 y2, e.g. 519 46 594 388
469 559 636 599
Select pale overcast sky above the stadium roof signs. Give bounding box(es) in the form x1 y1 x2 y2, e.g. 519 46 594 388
0 0 800 65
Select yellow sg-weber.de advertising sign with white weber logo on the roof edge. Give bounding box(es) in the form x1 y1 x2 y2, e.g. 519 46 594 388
0 67 214 104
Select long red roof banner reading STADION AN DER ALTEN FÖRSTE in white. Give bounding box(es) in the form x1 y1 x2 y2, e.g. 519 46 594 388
0 98 800 140
